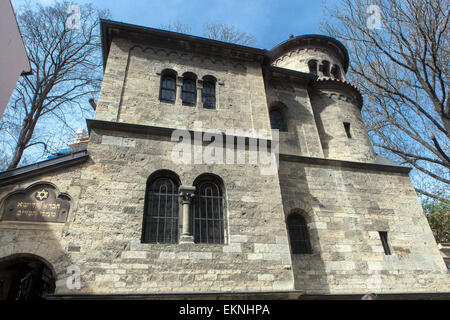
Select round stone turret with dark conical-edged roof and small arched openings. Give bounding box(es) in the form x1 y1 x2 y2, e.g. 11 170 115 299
271 35 375 162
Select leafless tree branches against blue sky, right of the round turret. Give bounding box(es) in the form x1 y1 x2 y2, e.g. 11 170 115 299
322 0 450 198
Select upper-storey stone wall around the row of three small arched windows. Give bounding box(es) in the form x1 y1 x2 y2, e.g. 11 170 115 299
95 38 270 136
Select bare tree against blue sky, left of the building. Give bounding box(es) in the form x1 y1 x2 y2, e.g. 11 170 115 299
2 1 108 169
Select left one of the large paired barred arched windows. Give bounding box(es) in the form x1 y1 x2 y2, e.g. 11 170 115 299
142 172 180 243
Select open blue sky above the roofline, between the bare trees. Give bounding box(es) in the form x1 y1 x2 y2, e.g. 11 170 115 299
12 0 335 49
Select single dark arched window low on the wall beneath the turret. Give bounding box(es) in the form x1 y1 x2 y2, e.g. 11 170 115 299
286 213 312 254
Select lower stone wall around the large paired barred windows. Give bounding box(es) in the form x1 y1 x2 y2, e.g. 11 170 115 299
0 129 293 294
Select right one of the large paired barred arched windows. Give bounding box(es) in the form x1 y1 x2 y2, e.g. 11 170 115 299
193 178 225 243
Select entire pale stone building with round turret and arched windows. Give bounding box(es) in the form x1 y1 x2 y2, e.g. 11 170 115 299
0 20 450 299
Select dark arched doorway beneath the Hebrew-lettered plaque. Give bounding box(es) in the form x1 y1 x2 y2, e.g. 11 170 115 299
0 254 56 300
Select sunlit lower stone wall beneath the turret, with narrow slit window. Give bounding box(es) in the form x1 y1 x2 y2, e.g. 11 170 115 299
280 161 450 294
